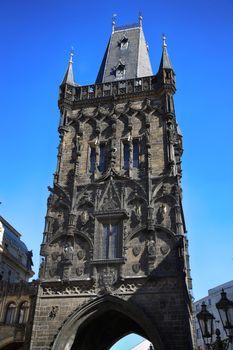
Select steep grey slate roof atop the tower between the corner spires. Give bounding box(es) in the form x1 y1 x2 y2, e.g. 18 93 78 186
96 24 153 83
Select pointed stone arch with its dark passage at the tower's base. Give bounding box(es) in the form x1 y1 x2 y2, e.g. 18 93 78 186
51 295 164 350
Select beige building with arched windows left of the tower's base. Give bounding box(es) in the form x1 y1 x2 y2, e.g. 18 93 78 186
0 216 37 350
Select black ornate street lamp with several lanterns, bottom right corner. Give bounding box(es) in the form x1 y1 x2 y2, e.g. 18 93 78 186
197 290 233 350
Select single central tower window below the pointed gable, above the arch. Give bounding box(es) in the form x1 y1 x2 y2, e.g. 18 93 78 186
101 223 120 259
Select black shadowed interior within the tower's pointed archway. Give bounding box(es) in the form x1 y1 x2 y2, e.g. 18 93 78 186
71 310 147 350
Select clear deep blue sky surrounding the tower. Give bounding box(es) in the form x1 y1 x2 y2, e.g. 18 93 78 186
0 0 233 348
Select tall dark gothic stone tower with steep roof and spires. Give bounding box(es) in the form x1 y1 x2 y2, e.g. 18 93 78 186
31 18 193 350
